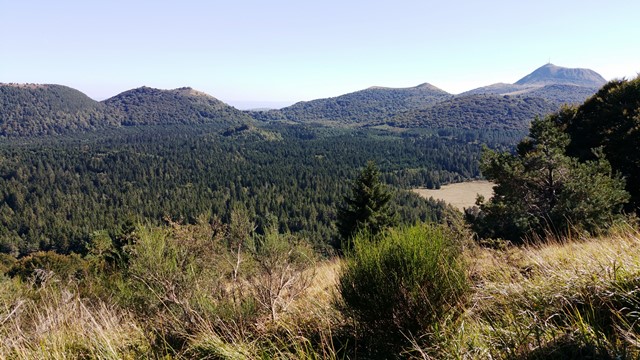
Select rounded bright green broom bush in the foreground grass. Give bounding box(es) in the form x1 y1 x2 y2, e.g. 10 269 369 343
338 225 469 349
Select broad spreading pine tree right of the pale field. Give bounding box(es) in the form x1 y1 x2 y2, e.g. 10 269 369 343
467 116 629 241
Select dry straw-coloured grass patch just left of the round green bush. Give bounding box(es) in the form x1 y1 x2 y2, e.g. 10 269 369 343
184 259 344 359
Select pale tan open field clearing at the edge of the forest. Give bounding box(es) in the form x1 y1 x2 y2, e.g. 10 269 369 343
413 181 495 211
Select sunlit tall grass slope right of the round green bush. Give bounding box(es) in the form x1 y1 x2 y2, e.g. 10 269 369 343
417 227 640 359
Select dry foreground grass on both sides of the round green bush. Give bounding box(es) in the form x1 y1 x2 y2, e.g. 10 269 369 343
0 227 640 359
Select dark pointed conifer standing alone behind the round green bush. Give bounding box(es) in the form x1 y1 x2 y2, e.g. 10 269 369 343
337 161 396 251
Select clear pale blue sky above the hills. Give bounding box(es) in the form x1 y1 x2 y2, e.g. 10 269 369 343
0 0 640 109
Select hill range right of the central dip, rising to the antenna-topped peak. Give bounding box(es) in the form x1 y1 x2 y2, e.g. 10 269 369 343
251 64 605 129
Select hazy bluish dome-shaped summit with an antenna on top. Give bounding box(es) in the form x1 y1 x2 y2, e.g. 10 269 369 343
515 63 607 88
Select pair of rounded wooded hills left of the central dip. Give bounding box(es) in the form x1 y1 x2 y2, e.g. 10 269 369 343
0 84 253 137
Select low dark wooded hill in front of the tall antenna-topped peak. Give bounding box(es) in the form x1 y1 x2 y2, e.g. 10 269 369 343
386 94 558 130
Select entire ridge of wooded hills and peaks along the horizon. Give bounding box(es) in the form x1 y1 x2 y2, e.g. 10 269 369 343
0 64 606 137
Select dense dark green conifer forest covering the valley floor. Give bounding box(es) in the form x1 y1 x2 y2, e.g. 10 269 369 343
0 125 504 254
